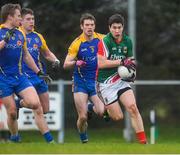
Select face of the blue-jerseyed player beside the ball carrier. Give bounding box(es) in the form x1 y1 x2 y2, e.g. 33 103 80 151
81 19 95 37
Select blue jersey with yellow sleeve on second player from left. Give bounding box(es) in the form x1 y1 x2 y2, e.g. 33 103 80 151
23 31 48 77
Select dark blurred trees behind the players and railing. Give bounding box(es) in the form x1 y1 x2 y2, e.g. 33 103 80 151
0 0 180 143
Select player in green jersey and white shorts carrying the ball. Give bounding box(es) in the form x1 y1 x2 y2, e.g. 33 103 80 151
97 14 147 144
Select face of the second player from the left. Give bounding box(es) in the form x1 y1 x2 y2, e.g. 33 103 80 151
22 14 35 32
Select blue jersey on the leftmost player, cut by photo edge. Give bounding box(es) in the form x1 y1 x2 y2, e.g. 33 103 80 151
0 25 26 76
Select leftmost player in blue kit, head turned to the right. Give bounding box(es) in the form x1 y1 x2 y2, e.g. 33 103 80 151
0 4 46 142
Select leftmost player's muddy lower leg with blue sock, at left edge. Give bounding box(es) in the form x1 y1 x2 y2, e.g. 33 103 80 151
2 95 21 142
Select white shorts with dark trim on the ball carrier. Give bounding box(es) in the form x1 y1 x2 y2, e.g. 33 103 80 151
98 79 131 105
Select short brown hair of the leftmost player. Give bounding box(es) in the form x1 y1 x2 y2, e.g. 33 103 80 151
1 3 21 23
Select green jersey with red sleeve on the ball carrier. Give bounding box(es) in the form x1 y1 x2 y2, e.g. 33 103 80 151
98 33 133 83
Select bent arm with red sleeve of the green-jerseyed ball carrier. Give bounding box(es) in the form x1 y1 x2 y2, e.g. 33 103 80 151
98 41 121 68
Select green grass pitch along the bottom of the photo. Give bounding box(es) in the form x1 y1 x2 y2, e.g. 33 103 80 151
0 127 180 154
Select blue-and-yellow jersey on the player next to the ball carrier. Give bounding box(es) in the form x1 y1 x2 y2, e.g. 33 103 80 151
68 33 103 79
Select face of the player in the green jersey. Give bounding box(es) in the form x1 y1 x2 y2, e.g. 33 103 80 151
109 23 124 39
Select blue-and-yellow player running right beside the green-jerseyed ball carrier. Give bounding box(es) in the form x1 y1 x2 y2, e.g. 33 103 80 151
64 13 104 143
